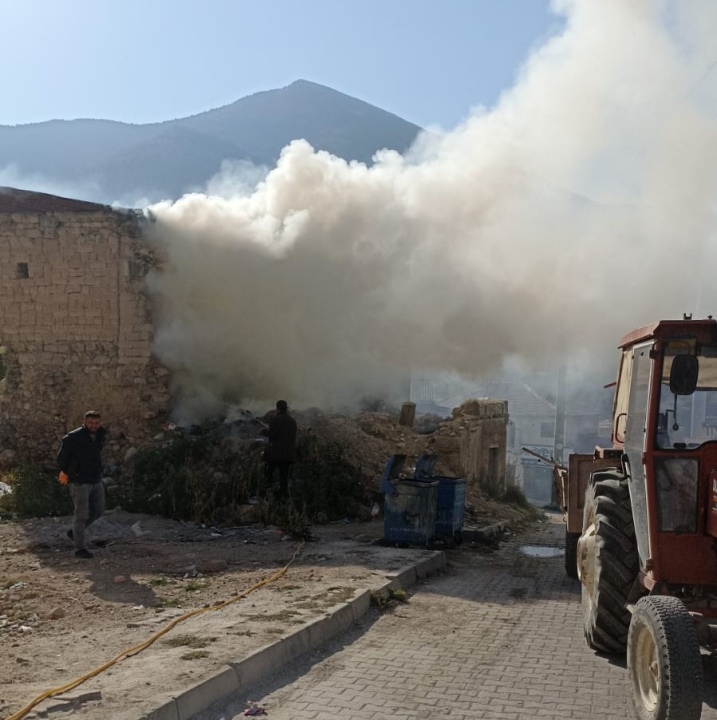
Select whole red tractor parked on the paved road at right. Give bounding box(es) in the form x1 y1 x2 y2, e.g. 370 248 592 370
556 317 717 720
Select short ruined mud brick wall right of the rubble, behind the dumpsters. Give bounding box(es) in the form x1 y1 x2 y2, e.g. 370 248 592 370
460 400 508 496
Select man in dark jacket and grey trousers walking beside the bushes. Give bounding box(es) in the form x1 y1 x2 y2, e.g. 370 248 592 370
57 410 107 558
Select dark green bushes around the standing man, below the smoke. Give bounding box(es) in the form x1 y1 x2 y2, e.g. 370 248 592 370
117 425 368 524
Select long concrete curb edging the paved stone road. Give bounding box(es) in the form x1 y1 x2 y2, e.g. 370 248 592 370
140 551 446 720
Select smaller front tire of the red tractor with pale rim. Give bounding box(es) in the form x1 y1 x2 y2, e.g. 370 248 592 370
627 595 703 720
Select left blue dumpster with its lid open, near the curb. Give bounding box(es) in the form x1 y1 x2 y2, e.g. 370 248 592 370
381 455 438 545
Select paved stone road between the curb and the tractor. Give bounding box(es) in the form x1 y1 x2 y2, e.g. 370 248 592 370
196 519 717 720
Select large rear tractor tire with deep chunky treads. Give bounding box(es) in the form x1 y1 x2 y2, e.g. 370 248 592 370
578 470 640 655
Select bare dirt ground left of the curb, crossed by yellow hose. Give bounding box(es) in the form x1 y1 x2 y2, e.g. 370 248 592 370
0 496 536 720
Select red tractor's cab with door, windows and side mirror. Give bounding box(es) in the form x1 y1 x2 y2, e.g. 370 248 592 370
613 320 717 590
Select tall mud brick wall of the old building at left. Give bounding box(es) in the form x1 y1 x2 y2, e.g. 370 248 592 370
0 206 169 461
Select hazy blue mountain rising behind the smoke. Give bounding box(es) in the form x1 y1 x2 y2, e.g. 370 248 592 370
0 80 420 202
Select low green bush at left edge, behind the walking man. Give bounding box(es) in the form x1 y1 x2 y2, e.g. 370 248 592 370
0 467 73 517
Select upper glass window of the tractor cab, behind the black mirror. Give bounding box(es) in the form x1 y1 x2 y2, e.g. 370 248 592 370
655 342 717 450
